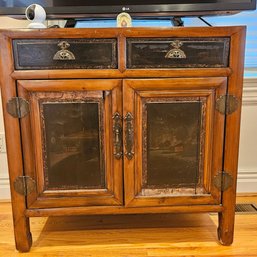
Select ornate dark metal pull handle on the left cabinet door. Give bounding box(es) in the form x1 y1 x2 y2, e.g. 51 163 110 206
112 112 122 160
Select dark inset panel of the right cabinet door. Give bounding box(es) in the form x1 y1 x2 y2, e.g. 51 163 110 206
142 97 206 194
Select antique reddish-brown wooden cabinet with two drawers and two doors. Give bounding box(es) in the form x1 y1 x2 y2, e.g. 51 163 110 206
0 27 245 252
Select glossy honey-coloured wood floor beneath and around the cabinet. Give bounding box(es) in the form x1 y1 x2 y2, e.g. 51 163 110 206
0 196 257 257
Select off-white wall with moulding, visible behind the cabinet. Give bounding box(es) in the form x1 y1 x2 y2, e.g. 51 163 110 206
0 17 257 199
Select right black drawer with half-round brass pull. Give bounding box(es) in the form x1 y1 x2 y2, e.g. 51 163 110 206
127 38 230 69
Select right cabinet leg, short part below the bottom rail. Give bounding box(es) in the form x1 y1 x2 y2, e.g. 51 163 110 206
218 207 235 245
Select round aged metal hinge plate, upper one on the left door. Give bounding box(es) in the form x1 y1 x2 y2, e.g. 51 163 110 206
7 97 29 118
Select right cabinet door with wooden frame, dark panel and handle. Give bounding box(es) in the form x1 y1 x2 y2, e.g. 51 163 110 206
123 77 227 206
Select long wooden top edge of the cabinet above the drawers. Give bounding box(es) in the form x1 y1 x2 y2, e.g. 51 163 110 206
0 26 246 38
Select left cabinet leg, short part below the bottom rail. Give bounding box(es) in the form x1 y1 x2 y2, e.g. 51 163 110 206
13 216 32 252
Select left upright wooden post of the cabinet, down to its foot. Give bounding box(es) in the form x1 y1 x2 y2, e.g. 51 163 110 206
0 35 32 252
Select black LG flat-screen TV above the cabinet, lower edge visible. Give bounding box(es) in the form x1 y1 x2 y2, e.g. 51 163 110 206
0 0 256 18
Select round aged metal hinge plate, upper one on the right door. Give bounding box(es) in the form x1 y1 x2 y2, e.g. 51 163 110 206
216 95 239 115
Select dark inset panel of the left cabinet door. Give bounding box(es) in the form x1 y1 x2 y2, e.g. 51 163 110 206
40 94 105 190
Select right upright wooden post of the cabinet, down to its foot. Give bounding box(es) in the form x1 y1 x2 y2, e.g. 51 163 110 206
218 27 246 245
